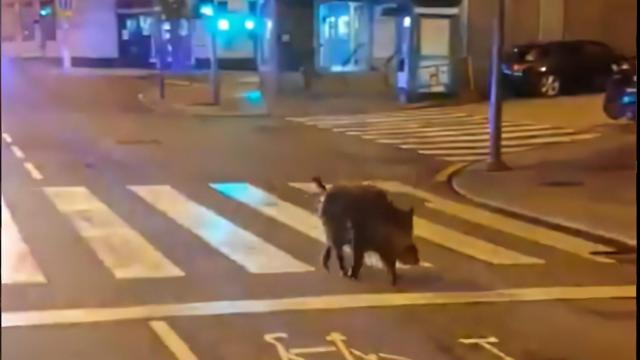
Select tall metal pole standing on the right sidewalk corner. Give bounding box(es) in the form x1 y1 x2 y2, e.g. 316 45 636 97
487 0 509 171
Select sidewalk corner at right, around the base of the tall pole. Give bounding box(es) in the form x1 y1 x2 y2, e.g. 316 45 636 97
452 124 637 246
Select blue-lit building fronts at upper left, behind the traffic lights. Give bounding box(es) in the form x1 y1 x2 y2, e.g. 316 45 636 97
2 0 255 69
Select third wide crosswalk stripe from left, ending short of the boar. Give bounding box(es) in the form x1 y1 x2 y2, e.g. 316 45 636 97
128 185 314 274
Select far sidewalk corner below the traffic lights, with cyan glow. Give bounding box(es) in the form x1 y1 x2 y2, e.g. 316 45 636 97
139 72 268 117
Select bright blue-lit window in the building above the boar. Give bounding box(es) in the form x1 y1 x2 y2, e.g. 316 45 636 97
316 1 371 72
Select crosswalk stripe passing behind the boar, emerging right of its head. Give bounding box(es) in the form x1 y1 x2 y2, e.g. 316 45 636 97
289 183 544 265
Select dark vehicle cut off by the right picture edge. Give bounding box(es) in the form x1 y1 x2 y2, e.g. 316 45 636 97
602 57 638 121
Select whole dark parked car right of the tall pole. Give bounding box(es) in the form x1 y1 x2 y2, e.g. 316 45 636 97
502 40 624 97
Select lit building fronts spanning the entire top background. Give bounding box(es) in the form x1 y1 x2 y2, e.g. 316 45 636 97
1 0 637 96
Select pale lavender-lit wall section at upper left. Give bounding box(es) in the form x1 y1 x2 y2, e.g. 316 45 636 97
69 0 118 59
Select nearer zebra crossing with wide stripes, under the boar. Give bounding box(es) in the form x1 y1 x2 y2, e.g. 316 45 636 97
1 181 615 284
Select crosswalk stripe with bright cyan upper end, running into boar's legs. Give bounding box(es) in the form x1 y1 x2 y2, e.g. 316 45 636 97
210 183 432 268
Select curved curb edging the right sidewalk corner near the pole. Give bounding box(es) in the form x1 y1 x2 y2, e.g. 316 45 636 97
447 167 637 249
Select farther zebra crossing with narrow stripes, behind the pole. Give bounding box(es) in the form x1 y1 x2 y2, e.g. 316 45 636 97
286 108 600 162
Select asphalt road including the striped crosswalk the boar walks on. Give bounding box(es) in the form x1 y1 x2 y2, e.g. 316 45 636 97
2 58 636 360
